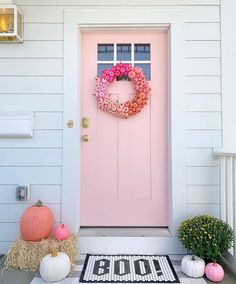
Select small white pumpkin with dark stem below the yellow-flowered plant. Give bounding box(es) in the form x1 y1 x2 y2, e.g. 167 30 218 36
181 255 205 278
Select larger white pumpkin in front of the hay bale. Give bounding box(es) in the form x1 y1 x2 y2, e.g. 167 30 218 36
39 251 71 282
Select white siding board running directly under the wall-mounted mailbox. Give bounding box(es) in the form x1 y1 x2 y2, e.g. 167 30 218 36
0 130 62 149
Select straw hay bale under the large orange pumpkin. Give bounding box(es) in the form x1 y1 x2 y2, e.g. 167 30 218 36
3 234 77 272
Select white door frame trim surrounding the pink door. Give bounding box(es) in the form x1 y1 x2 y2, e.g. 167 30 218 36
61 6 187 236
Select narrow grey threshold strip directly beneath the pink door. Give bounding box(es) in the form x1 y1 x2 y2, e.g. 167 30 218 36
78 227 171 237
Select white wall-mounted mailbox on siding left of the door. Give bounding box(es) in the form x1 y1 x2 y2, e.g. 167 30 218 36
0 112 34 138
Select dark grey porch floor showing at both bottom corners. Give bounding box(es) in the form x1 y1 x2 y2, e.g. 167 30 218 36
0 257 236 284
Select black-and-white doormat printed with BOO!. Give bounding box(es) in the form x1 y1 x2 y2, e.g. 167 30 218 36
80 254 180 283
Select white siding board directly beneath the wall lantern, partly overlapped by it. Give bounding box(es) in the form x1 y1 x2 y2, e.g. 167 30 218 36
0 41 63 58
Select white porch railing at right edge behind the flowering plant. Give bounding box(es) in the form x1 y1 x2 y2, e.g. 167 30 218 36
213 150 236 257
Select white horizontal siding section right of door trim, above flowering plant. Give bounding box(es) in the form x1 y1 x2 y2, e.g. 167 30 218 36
185 7 222 217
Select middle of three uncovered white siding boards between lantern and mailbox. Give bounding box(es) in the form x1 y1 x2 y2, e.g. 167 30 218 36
0 76 62 94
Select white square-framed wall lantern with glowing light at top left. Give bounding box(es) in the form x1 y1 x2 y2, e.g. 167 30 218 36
0 1 23 43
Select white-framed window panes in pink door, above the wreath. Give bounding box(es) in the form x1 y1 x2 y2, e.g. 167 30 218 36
97 43 151 80
